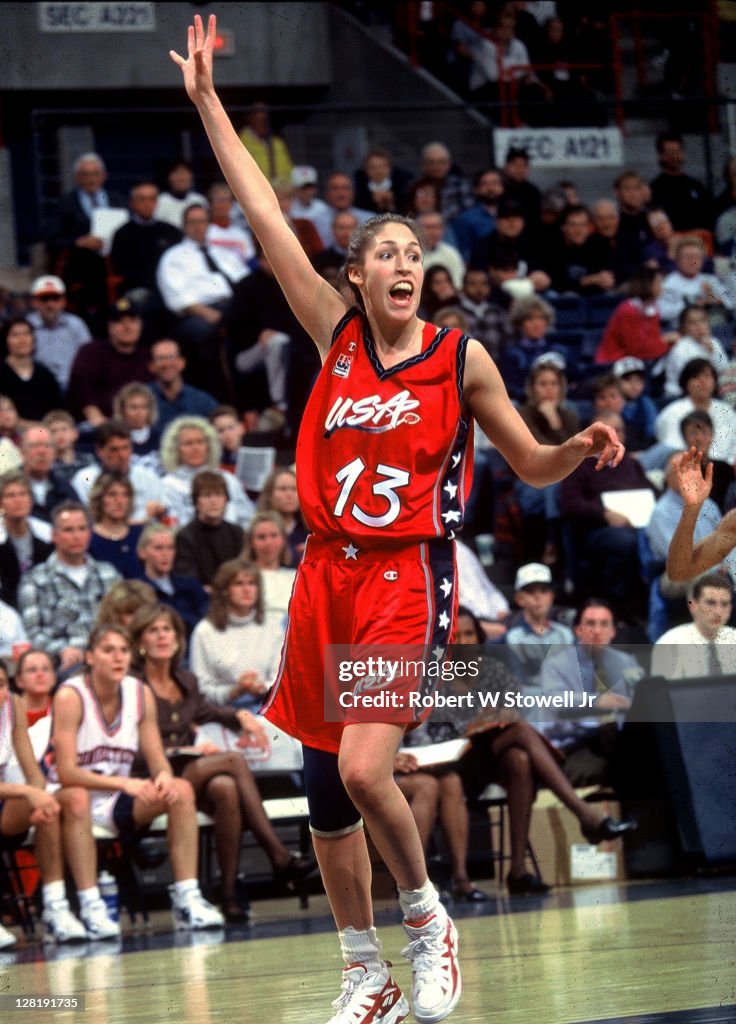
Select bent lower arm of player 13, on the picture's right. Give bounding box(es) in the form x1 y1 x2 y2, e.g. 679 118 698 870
464 341 623 487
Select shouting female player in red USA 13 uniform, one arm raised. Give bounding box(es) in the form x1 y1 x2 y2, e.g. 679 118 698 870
171 15 623 1024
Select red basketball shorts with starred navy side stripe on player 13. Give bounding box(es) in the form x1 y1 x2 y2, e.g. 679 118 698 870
262 537 458 753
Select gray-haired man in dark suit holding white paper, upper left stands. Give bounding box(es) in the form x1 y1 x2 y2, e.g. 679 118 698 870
48 153 127 326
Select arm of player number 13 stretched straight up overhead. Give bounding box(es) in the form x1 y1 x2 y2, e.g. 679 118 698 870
170 14 346 357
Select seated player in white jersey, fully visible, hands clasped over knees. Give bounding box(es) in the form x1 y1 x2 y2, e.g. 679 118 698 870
48 625 224 931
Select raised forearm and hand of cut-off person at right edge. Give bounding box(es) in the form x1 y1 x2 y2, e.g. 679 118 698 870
667 447 736 581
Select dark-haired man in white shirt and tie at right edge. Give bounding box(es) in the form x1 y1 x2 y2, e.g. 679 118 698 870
650 572 736 679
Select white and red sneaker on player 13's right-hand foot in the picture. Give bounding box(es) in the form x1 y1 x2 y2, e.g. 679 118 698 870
402 903 463 1024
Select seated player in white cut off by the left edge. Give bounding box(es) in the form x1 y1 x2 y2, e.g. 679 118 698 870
0 662 93 949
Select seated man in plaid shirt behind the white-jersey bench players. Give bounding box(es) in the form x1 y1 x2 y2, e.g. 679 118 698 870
18 502 121 672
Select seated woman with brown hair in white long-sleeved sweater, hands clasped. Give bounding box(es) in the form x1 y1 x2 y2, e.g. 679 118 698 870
189 558 284 711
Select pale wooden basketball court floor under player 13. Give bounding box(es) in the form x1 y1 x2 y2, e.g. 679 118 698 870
0 878 736 1024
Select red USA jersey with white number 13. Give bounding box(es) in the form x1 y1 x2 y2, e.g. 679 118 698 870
297 309 472 547
